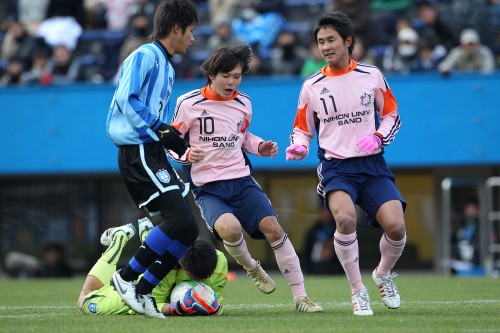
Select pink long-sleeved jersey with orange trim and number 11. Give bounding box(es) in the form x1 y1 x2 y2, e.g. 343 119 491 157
291 60 401 160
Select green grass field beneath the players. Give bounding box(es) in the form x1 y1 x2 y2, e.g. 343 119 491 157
0 272 500 333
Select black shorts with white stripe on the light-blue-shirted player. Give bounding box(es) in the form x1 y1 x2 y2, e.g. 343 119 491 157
118 142 189 213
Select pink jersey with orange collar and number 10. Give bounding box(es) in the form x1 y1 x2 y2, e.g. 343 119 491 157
171 86 263 186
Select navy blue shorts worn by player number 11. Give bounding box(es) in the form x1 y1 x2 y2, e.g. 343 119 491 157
317 154 406 226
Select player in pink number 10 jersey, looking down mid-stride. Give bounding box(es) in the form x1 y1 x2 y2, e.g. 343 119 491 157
171 45 323 312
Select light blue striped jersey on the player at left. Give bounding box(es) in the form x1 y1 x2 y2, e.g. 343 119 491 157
106 42 175 146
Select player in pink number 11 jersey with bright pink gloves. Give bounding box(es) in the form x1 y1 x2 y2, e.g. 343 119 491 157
286 11 406 316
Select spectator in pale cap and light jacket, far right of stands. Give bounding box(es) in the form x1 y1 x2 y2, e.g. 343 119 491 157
438 28 495 76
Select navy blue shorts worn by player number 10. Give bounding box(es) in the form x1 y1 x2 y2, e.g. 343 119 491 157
193 176 278 240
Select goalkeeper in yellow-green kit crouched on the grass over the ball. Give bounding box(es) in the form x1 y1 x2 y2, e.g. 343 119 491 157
77 218 227 315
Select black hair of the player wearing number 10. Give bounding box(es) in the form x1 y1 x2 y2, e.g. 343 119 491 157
200 44 253 83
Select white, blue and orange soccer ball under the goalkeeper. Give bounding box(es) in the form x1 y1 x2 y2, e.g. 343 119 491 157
170 280 221 316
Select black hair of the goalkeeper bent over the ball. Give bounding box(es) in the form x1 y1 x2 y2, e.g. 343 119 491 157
179 239 217 281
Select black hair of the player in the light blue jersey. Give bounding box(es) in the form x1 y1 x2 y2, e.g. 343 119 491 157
149 0 199 40
